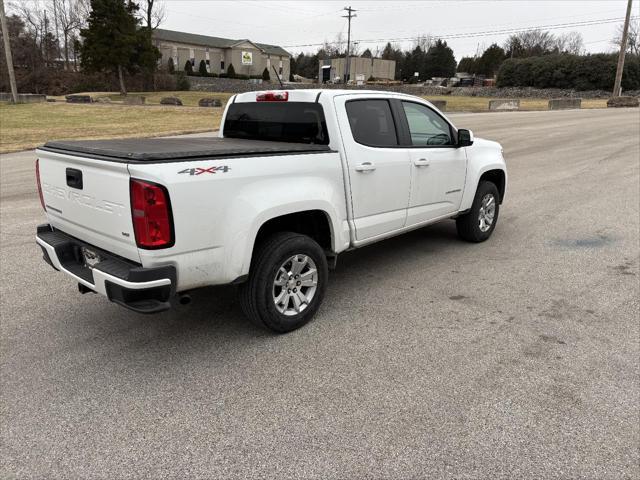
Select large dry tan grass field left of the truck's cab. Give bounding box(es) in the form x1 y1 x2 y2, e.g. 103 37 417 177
0 103 222 153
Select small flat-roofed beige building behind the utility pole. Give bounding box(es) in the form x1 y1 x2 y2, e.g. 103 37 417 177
318 57 396 83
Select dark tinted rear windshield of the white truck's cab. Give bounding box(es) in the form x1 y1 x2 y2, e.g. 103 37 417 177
224 102 329 145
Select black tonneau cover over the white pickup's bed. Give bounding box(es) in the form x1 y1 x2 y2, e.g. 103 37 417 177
40 137 331 163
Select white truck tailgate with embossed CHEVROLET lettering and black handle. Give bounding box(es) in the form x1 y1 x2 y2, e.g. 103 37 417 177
36 150 140 262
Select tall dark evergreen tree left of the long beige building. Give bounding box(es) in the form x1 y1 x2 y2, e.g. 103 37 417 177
80 0 160 95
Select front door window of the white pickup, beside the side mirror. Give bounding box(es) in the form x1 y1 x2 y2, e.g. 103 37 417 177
402 102 453 146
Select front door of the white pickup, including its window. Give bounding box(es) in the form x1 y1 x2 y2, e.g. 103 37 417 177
401 101 467 226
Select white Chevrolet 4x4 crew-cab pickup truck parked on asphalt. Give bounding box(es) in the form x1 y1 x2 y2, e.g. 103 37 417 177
36 90 507 332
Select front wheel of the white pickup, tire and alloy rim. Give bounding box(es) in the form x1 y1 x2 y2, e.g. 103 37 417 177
456 182 500 242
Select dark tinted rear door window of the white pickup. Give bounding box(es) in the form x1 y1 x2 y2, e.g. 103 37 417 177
347 100 398 147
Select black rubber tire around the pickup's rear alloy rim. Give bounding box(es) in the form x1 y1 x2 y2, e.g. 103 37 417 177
239 232 329 333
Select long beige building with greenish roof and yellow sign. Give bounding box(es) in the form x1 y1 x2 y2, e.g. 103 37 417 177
153 28 291 81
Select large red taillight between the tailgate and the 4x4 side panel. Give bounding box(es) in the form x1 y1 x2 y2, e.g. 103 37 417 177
131 179 174 249
